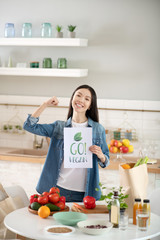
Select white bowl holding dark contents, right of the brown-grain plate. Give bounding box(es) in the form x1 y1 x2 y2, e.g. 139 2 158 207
77 219 113 235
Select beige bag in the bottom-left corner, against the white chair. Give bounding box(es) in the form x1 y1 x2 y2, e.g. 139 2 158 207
0 184 24 239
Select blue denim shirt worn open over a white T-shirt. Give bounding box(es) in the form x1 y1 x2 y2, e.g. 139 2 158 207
23 115 109 200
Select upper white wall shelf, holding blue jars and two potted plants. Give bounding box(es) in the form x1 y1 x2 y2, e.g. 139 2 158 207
0 38 88 47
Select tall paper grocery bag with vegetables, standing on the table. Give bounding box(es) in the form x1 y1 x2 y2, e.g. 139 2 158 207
119 163 148 217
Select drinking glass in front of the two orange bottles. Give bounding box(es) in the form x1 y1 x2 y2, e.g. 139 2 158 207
136 209 149 231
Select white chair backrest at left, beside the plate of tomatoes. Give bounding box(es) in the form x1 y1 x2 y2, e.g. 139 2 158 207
4 185 29 207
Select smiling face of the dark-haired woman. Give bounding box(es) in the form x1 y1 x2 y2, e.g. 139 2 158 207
72 88 92 113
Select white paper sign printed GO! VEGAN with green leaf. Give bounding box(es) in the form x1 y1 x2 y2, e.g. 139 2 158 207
64 128 92 168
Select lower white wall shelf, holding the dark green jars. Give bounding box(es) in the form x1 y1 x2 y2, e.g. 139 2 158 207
0 67 88 77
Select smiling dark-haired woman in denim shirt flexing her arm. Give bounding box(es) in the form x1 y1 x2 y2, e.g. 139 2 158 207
24 85 109 202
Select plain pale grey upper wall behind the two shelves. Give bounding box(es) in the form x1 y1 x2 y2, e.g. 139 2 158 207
0 0 160 100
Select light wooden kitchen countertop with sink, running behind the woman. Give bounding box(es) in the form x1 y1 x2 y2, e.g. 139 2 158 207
0 147 160 173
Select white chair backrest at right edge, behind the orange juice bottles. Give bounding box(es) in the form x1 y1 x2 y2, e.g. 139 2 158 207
149 188 160 216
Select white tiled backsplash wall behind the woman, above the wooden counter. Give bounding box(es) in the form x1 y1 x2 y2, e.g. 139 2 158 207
0 95 160 158
